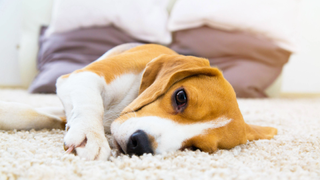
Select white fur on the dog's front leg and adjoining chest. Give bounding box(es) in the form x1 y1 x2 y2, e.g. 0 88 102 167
57 72 141 160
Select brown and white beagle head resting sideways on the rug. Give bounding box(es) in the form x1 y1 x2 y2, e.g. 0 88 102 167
111 55 277 155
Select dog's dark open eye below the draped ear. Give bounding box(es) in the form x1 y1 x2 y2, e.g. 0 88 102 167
172 88 188 113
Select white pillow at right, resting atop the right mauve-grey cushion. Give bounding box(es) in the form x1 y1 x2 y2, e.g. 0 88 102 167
168 0 300 51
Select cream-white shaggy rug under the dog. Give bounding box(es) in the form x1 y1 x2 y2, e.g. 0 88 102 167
0 89 320 180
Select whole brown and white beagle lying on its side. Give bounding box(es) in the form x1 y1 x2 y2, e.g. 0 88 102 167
0 43 277 160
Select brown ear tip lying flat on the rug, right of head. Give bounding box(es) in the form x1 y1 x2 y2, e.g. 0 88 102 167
246 124 278 141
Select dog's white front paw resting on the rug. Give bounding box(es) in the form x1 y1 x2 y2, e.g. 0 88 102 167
64 126 111 160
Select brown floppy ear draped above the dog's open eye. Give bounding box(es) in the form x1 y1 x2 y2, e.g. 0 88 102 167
122 55 222 114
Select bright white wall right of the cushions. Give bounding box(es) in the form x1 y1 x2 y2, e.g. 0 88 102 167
282 0 320 93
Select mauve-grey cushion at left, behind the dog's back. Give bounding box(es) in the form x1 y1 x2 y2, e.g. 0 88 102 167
29 26 141 93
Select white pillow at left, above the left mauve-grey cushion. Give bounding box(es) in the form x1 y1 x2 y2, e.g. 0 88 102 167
46 0 171 44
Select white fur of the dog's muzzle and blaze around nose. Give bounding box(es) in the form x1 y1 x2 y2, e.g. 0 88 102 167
111 116 231 154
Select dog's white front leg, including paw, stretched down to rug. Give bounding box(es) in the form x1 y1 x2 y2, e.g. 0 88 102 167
57 72 111 160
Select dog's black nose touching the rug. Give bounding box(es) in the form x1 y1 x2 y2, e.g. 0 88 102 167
127 130 153 156
